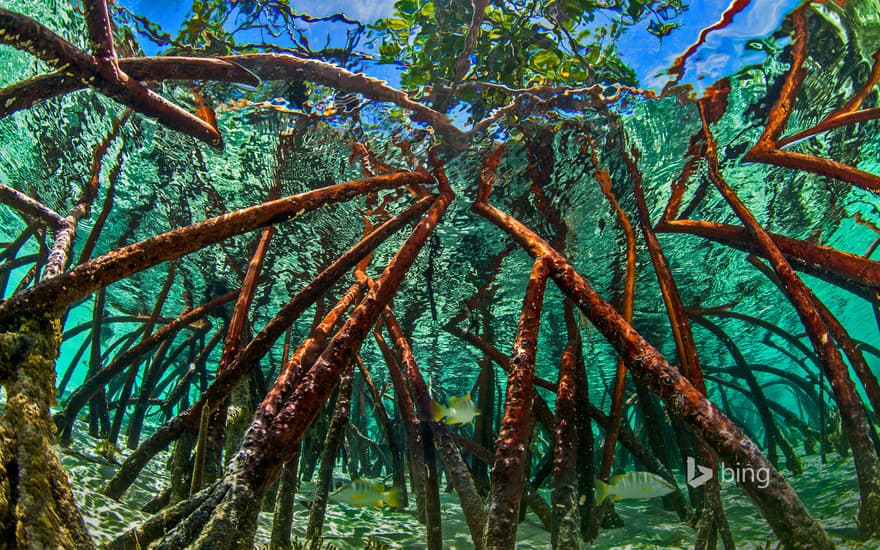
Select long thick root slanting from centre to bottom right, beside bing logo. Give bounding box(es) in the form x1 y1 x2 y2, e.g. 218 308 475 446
472 193 833 548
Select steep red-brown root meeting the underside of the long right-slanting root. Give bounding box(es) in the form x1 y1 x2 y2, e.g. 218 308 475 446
486 258 548 549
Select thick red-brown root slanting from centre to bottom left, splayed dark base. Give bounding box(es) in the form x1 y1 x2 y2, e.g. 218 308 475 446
147 182 453 549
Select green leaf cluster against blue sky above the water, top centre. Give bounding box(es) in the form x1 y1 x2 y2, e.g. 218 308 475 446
372 0 686 115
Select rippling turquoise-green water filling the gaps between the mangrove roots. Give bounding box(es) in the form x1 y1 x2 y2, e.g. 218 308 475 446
0 0 880 548
